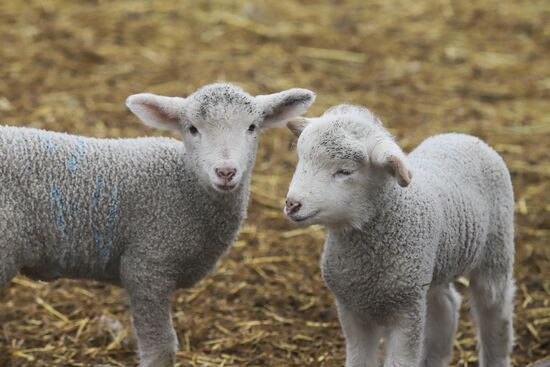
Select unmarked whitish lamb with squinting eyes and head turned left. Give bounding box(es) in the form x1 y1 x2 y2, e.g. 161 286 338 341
285 105 514 367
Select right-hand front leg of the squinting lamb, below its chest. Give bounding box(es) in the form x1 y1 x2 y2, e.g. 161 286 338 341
384 297 426 367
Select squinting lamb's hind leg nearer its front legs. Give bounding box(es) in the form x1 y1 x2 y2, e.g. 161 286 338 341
424 284 461 367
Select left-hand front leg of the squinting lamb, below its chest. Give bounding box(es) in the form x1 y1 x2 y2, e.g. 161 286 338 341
336 301 380 367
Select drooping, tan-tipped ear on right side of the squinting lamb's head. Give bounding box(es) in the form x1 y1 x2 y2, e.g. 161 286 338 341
371 138 412 187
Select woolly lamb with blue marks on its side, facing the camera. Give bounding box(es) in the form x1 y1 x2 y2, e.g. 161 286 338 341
0 84 315 367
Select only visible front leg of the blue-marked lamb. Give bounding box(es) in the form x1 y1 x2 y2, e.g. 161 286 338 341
123 262 178 367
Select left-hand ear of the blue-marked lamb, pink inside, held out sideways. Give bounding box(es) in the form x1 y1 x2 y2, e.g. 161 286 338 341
126 93 185 130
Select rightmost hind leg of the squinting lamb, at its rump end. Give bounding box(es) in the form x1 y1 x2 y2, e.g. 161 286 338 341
470 273 515 367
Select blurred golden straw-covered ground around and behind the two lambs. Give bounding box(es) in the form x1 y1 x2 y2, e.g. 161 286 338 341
0 0 550 367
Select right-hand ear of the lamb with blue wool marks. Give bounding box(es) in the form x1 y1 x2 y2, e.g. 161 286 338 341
256 88 315 128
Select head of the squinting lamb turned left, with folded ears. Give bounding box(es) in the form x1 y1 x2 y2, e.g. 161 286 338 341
285 105 412 226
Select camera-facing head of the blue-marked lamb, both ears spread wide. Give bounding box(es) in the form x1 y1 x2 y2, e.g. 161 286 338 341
126 83 315 192
